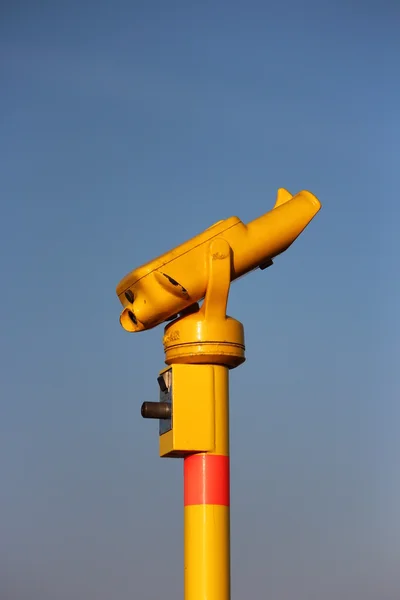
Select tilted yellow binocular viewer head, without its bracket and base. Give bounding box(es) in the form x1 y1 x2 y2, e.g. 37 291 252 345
117 188 321 332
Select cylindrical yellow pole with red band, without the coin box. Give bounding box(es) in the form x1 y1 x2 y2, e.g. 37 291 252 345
184 365 230 600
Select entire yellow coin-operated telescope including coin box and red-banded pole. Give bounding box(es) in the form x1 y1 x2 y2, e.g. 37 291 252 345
117 189 321 600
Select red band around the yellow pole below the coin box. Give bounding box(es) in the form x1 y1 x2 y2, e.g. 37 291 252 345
183 454 229 506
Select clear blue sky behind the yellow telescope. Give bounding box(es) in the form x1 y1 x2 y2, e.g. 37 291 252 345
0 0 400 600
